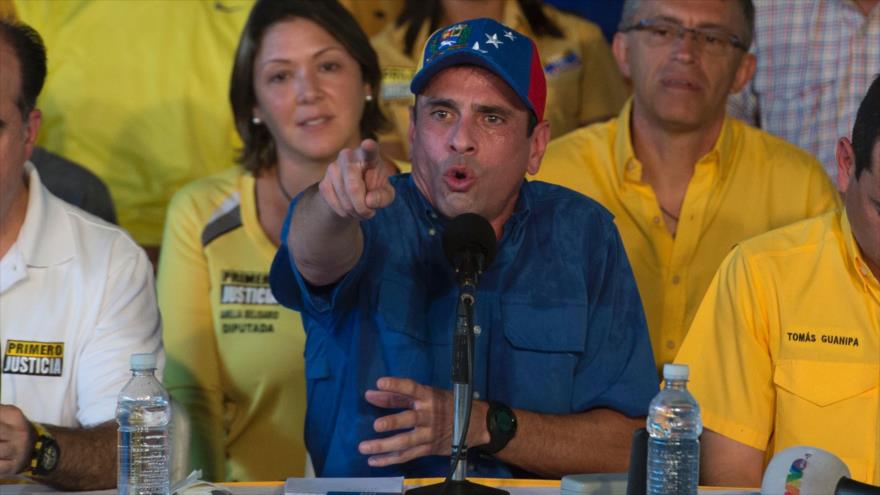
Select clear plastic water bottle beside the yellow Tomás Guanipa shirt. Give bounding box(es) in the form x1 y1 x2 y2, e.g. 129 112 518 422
648 364 703 495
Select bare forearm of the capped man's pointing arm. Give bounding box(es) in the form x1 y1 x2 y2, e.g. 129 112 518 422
287 184 364 286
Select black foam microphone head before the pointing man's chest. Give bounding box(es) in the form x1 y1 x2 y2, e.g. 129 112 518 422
443 213 496 286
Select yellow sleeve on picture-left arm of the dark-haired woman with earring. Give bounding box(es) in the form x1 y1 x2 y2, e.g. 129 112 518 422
158 189 226 481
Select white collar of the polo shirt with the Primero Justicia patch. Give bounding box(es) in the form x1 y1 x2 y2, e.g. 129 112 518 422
15 161 76 268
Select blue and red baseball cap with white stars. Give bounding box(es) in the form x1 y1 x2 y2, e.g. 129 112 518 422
410 17 547 122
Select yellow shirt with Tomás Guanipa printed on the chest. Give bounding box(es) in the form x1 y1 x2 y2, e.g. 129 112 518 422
676 212 880 484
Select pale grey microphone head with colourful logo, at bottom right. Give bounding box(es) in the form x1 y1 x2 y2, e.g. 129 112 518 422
761 445 849 495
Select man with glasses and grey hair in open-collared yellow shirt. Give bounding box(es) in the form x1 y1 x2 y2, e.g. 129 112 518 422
536 0 839 367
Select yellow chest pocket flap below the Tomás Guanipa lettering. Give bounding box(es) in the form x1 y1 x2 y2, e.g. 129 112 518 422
773 360 880 407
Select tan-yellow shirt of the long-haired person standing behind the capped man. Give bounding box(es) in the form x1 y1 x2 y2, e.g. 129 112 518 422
370 1 629 156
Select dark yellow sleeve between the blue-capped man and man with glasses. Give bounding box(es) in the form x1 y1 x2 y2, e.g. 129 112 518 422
579 28 630 126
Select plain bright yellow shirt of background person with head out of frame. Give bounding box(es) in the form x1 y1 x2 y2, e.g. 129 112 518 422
15 0 253 245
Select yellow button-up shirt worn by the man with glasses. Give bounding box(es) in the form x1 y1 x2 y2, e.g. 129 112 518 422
535 104 840 367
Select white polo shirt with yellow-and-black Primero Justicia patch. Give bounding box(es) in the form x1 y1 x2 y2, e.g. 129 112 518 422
0 162 165 427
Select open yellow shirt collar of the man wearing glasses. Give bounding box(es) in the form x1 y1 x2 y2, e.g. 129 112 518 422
614 97 736 184
